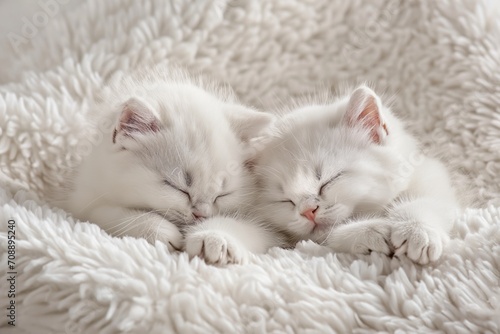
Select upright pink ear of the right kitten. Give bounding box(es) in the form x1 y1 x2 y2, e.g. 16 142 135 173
344 86 389 144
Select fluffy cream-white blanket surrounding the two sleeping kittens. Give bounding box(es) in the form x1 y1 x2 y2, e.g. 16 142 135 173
0 0 500 333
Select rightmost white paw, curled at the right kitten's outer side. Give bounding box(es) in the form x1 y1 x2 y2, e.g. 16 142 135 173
391 221 449 264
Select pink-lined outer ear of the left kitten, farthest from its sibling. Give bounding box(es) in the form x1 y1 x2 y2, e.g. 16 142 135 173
113 98 160 143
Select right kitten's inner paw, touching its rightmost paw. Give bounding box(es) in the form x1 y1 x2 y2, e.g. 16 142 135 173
352 222 393 255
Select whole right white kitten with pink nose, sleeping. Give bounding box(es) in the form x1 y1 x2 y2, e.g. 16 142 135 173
254 86 458 264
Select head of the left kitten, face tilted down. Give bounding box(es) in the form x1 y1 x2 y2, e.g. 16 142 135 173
109 82 274 225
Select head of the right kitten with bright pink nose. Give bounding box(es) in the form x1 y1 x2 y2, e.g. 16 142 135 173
254 86 413 242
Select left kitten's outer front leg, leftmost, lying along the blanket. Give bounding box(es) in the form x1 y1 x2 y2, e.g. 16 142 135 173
89 206 183 251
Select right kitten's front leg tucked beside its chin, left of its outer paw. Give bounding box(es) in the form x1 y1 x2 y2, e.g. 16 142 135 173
325 218 392 255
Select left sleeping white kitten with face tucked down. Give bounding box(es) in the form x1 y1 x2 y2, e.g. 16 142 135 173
63 69 273 249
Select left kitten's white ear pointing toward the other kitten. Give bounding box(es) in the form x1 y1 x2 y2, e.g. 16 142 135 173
224 105 276 150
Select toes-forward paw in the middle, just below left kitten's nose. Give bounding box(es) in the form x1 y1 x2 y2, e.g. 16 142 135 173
186 231 248 265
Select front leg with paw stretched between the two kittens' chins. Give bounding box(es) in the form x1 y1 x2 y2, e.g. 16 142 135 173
185 216 277 265
